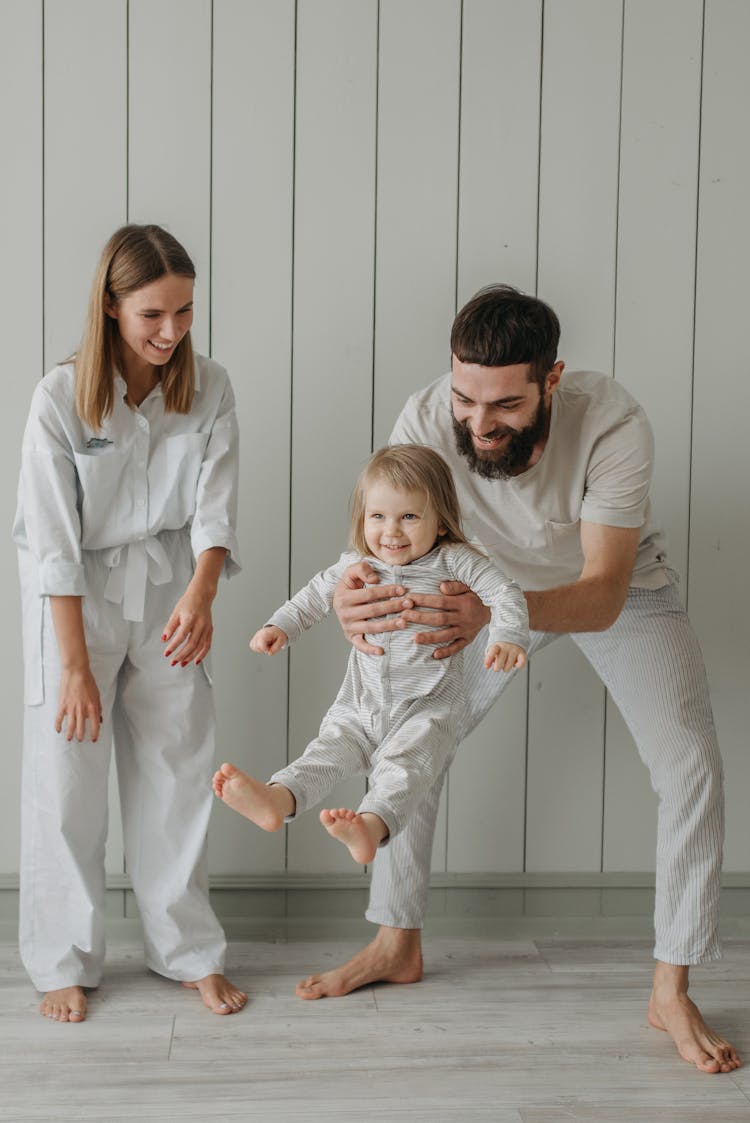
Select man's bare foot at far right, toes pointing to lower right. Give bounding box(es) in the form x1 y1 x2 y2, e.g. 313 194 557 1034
649 960 742 1072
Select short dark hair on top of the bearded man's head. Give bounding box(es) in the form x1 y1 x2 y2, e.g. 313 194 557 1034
450 284 560 386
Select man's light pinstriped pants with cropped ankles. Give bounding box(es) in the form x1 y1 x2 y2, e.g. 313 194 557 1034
366 586 724 965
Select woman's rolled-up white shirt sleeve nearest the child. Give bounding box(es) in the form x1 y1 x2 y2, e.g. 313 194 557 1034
191 378 240 577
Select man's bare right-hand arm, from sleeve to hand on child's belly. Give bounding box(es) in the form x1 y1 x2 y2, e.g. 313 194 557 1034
402 520 640 659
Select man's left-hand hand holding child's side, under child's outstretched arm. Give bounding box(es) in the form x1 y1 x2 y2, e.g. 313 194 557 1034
333 562 406 655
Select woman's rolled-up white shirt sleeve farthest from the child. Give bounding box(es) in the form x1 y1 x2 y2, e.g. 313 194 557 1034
20 385 86 596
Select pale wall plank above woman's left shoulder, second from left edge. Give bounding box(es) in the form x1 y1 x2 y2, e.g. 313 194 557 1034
44 0 127 873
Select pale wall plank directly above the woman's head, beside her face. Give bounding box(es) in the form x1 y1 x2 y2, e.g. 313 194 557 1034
128 0 211 354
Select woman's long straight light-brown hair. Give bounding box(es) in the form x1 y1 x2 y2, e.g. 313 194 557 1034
72 223 195 429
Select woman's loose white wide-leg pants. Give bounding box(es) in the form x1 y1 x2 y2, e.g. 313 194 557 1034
20 531 226 990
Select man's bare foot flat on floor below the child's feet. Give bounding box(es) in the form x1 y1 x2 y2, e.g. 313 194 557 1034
295 928 422 999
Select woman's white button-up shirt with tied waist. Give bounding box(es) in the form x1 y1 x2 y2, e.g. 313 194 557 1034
13 355 239 620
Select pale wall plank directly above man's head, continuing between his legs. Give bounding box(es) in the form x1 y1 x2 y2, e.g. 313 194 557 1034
448 0 541 871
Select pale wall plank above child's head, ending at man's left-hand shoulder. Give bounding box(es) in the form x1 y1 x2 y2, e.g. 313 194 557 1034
373 0 460 869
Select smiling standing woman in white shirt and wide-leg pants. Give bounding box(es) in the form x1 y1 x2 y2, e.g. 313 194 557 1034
13 226 246 1022
